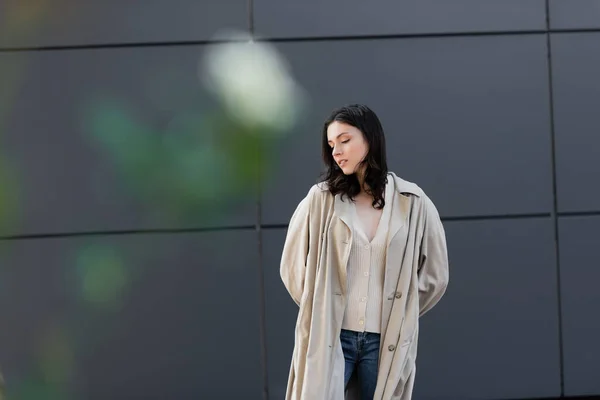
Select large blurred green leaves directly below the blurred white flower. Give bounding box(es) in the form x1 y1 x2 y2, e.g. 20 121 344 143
87 95 275 222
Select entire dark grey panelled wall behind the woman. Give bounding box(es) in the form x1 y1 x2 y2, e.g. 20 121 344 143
0 0 600 400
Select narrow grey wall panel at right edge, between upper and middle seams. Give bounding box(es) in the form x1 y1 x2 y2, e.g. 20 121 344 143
551 33 600 211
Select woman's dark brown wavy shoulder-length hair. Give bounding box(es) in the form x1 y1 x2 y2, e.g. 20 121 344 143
322 104 388 209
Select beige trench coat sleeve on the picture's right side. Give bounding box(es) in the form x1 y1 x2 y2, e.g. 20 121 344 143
418 197 449 316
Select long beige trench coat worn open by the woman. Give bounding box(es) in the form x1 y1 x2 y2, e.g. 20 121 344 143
280 173 449 400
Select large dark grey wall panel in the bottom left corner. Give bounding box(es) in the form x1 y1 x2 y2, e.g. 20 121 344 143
0 231 262 400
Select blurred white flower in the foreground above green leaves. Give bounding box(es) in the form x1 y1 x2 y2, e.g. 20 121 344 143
200 28 304 132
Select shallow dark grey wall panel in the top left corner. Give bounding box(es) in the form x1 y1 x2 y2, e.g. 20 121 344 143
0 0 248 47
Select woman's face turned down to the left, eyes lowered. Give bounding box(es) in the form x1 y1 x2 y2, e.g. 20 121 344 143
327 121 369 175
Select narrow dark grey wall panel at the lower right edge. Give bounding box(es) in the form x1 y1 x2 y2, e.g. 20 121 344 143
559 216 600 396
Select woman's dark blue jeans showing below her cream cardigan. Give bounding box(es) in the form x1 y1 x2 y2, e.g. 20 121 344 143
340 329 380 400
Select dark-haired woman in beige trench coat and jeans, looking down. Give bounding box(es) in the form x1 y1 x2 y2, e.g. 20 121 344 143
281 105 448 400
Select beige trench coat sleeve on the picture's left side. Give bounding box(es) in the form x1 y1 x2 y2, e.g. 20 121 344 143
279 192 310 305
